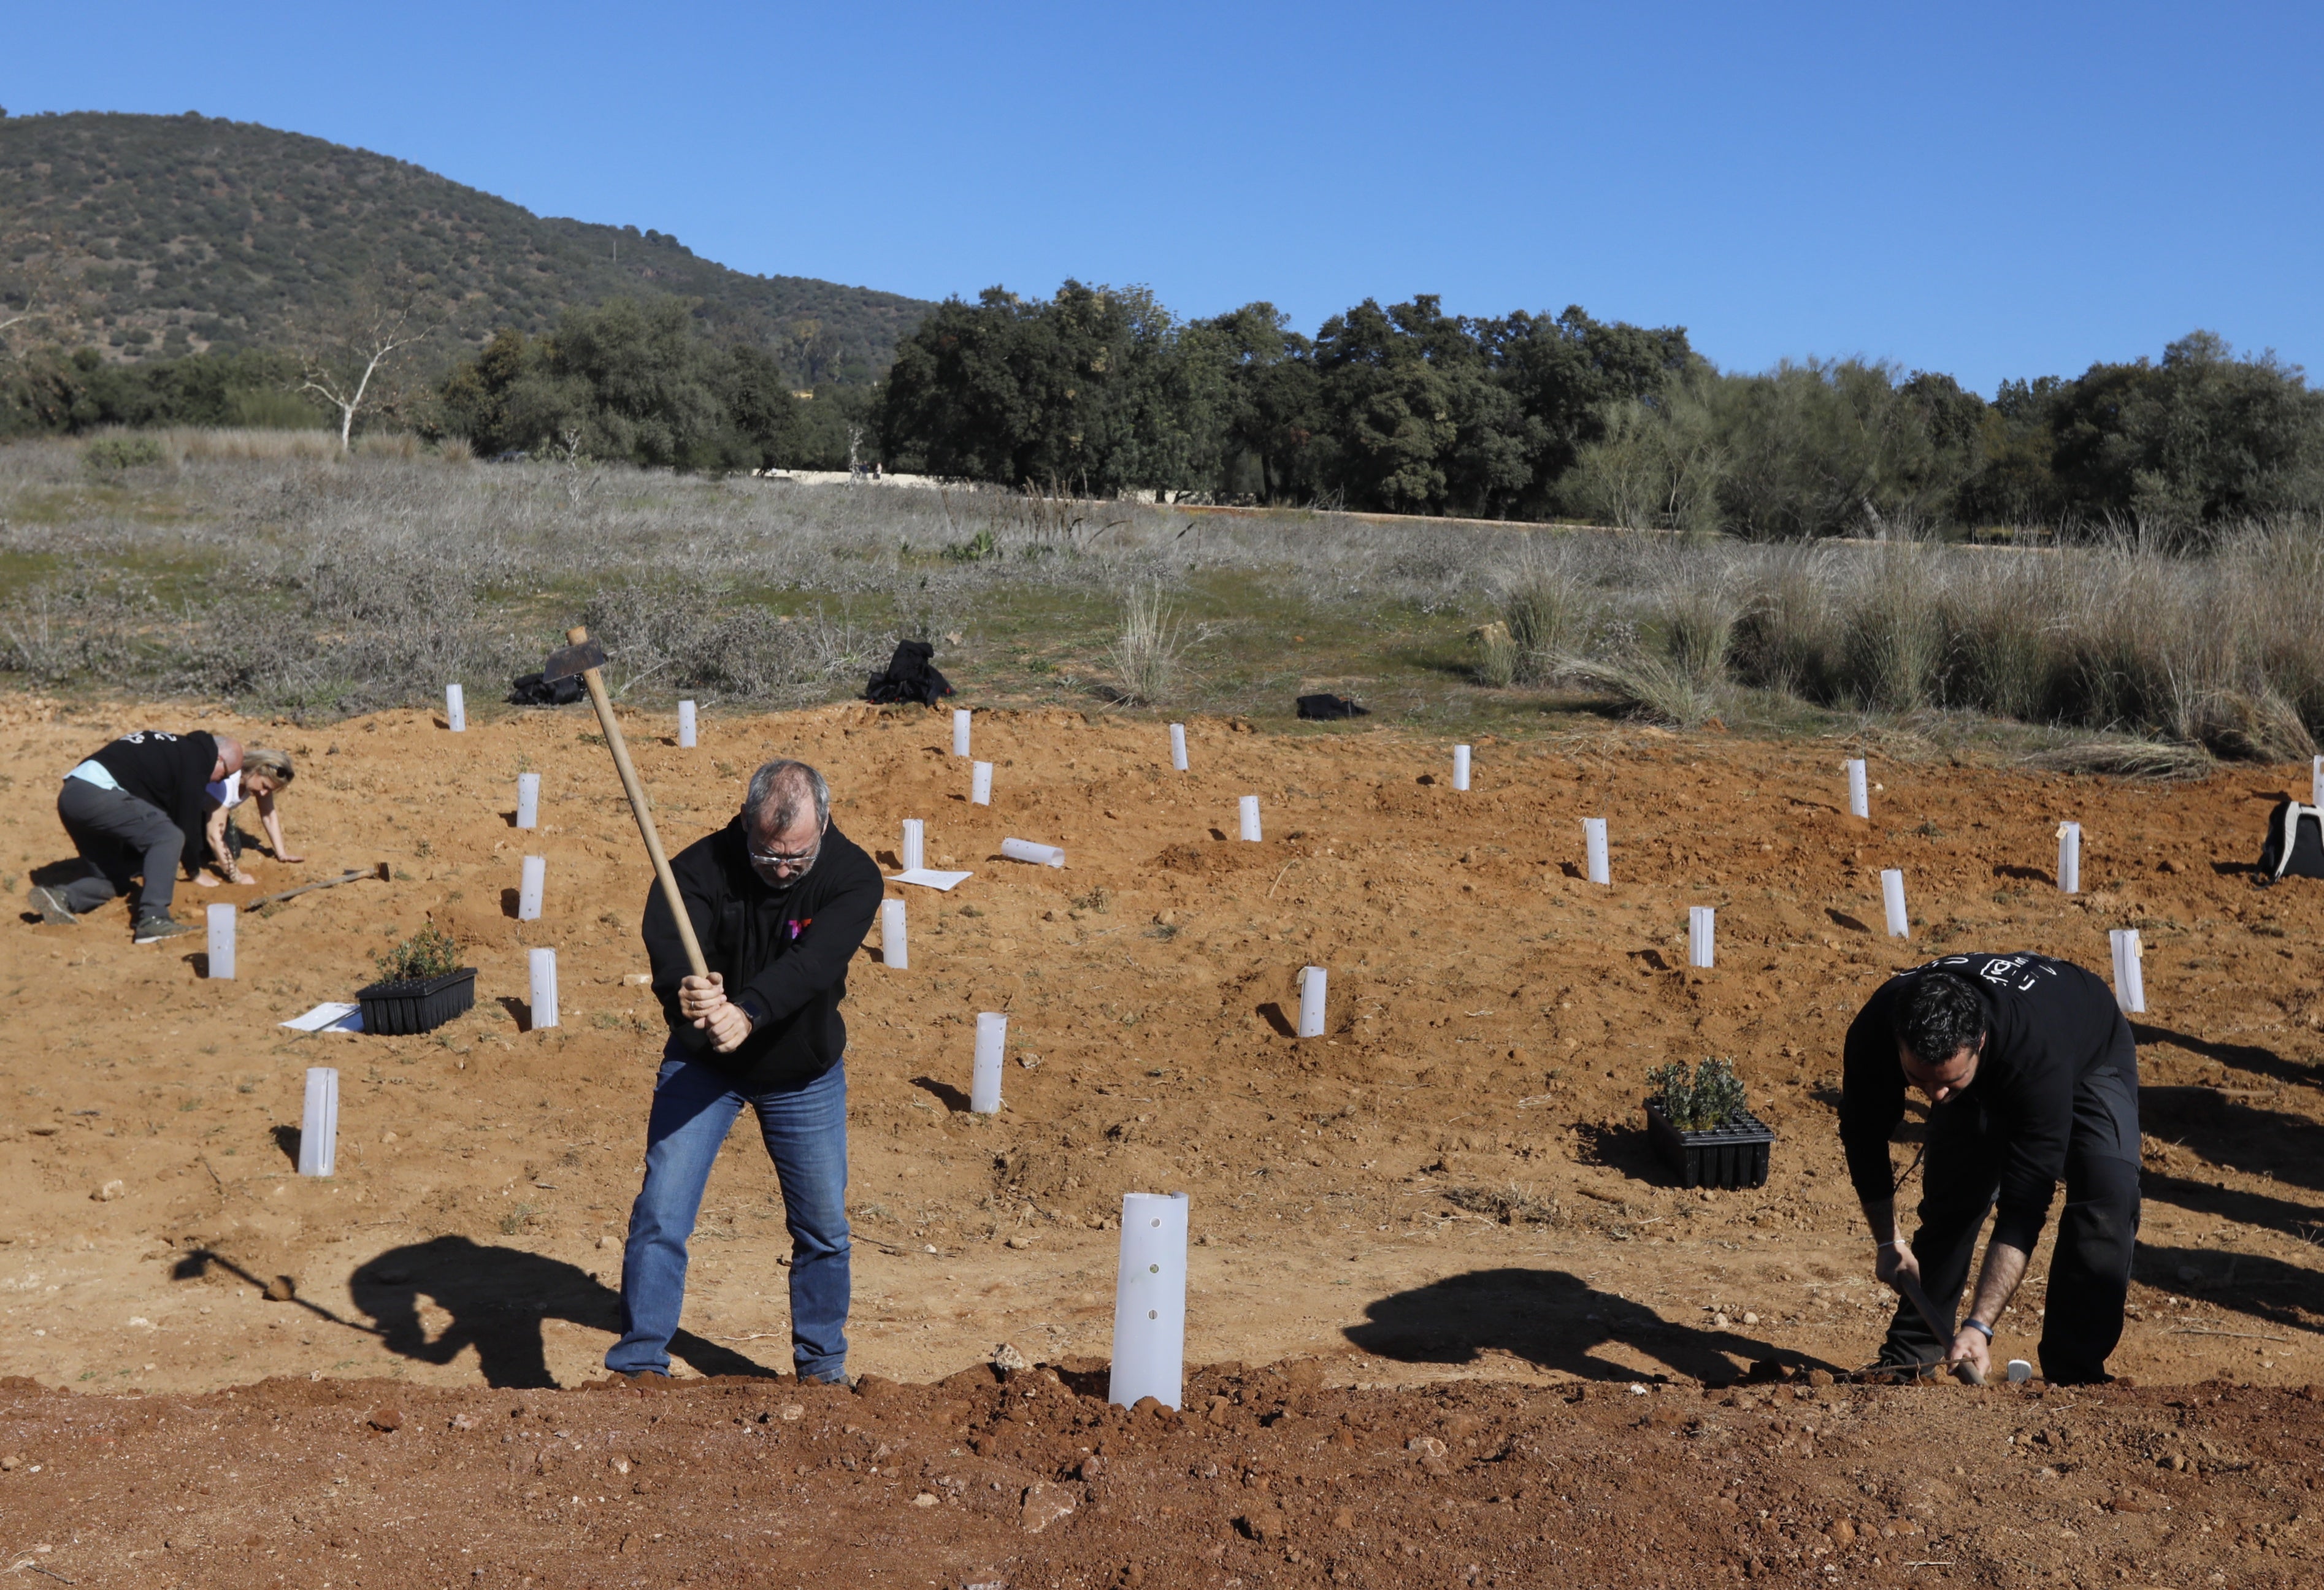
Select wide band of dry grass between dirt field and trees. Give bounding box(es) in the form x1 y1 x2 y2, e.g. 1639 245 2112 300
0 430 2324 772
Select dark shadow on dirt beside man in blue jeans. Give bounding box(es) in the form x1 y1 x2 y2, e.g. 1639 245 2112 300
347 1237 778 1388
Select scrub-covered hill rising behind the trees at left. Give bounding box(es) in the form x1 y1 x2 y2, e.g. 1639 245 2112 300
0 112 934 384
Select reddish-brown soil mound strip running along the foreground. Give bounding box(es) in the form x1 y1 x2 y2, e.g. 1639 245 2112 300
0 1360 2324 1590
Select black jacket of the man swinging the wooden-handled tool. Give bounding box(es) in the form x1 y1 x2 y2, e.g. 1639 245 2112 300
642 816 883 1093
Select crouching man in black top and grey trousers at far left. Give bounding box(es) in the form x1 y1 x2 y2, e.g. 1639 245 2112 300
30 730 242 944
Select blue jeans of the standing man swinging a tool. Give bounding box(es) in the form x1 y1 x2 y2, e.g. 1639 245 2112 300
604 1044 851 1378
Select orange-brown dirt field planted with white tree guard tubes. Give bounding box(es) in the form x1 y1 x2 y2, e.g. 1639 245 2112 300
0 697 2324 1585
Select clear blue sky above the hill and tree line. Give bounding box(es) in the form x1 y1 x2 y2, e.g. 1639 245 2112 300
0 0 2324 395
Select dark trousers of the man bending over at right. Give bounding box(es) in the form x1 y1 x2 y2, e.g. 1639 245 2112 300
1880 1041 2138 1385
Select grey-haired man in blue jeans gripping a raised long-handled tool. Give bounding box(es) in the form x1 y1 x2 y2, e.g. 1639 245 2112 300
604 760 883 1381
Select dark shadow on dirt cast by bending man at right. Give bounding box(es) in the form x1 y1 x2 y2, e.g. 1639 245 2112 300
1343 1267 1838 1385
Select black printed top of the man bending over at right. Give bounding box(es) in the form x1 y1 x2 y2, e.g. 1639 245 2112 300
1841 953 2138 1251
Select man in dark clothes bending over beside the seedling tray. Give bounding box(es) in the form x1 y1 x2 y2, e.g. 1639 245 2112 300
1841 953 2138 1385
